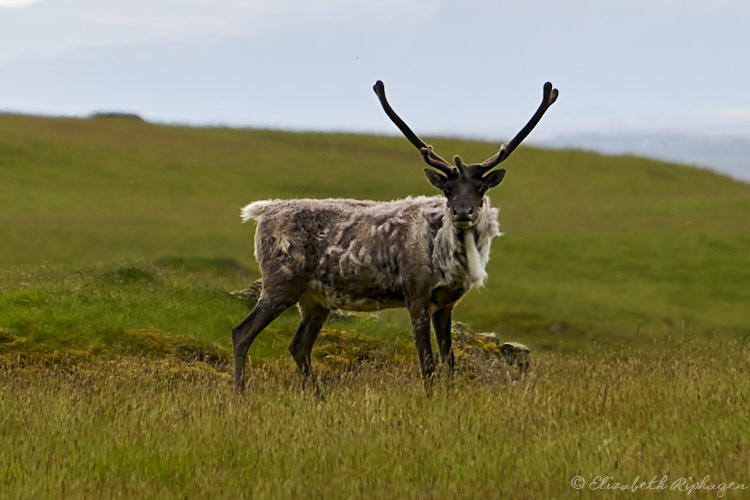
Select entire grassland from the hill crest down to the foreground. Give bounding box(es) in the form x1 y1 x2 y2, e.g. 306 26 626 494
0 115 750 498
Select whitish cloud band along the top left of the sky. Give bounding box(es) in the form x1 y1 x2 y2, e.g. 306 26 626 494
0 0 441 63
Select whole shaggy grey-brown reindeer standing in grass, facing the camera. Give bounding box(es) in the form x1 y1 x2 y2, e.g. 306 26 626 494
232 81 558 393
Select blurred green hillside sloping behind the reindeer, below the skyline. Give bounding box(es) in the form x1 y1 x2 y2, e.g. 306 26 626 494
0 115 750 356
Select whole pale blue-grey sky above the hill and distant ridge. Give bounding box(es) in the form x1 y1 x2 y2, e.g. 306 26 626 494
0 0 750 141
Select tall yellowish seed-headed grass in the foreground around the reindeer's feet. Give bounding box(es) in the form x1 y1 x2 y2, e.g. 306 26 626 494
0 341 750 498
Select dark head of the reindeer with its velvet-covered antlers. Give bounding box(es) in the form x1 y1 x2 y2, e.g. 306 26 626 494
373 80 558 229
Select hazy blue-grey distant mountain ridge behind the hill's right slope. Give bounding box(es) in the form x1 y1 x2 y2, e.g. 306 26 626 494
543 133 750 182
